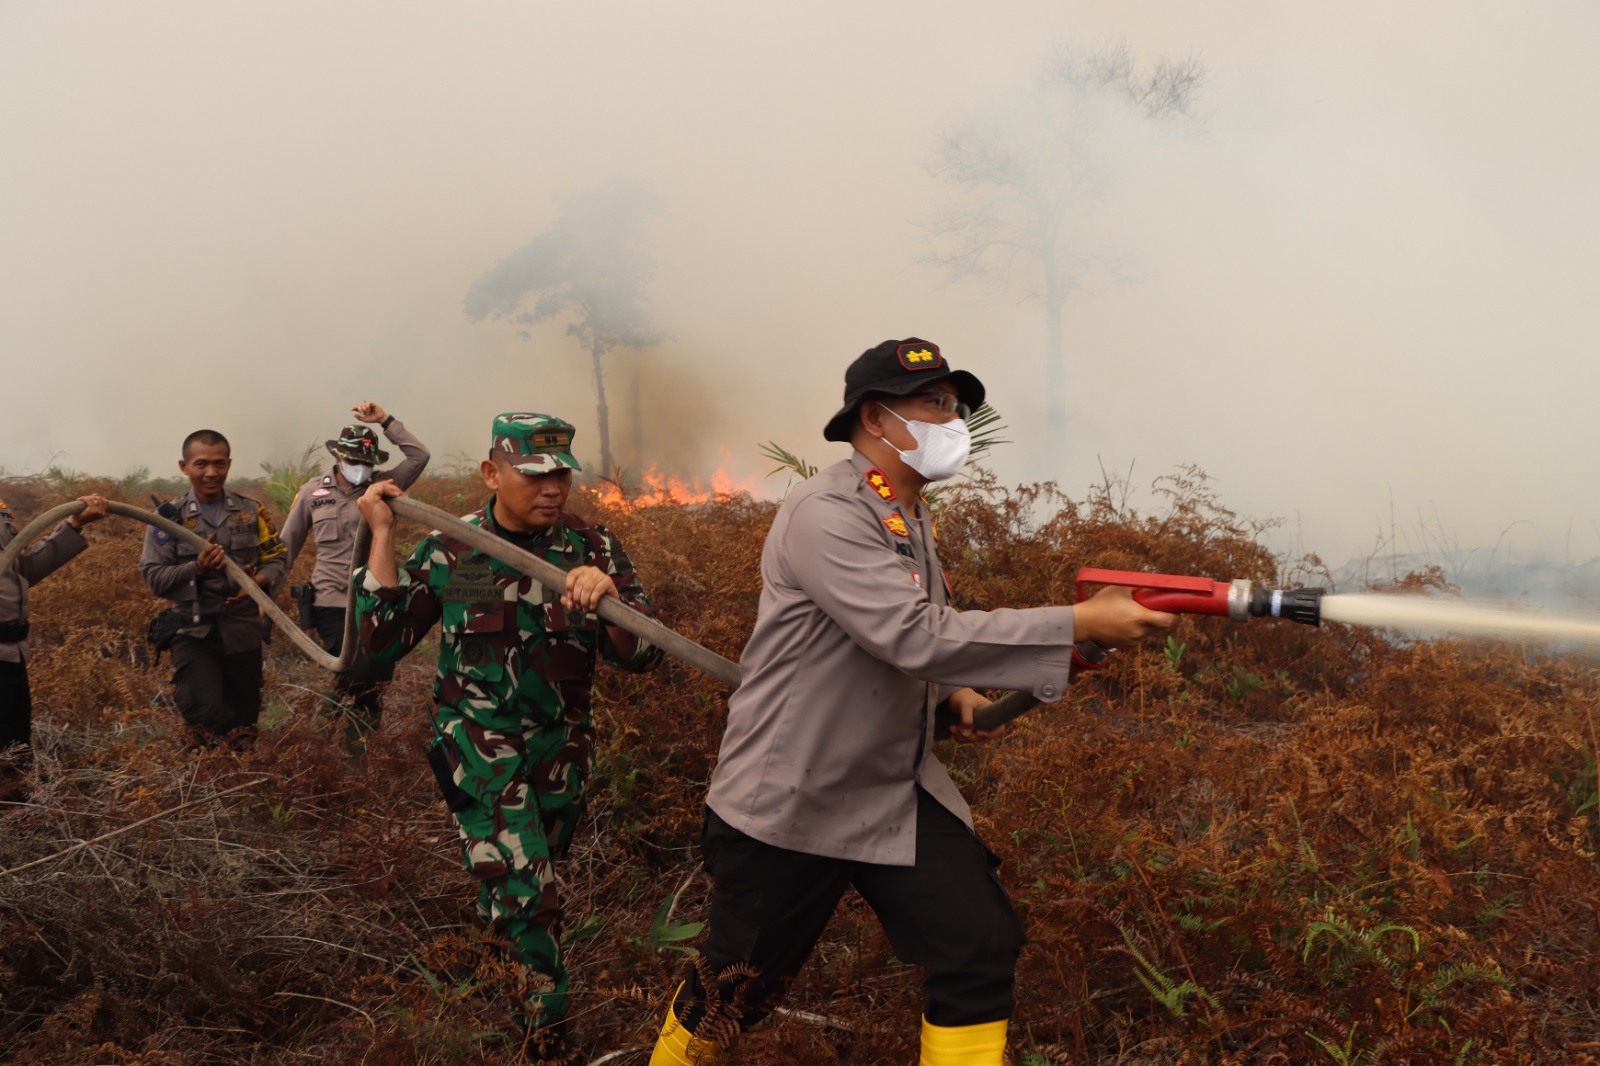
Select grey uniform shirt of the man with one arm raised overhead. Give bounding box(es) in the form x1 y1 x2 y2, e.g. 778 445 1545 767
283 419 430 607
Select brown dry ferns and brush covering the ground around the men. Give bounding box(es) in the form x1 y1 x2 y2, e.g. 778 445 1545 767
0 472 1600 1066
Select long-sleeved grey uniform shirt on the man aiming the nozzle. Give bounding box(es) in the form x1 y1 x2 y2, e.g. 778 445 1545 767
706 451 1072 866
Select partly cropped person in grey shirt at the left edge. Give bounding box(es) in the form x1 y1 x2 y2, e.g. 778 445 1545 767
0 495 106 776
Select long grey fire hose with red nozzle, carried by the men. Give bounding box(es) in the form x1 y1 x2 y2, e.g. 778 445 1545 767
0 496 1322 730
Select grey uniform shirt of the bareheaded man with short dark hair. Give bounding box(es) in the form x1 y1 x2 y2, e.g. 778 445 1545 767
139 490 288 655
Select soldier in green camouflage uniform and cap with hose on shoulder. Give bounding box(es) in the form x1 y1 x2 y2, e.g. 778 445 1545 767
352 413 661 1052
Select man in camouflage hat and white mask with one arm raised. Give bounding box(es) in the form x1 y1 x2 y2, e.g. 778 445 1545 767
283 400 429 739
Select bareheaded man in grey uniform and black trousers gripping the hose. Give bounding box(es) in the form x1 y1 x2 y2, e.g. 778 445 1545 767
139 429 288 744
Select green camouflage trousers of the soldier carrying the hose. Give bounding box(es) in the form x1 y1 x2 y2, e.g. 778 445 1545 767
429 714 594 1026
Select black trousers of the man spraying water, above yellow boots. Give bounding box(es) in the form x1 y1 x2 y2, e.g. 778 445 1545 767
677 787 1024 1031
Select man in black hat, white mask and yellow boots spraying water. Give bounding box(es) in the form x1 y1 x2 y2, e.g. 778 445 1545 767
651 338 1176 1066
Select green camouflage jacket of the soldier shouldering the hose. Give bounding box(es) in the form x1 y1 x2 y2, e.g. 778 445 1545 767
350 498 661 733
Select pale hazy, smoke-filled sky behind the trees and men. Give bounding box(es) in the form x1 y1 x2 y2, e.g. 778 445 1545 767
0 0 1600 576
